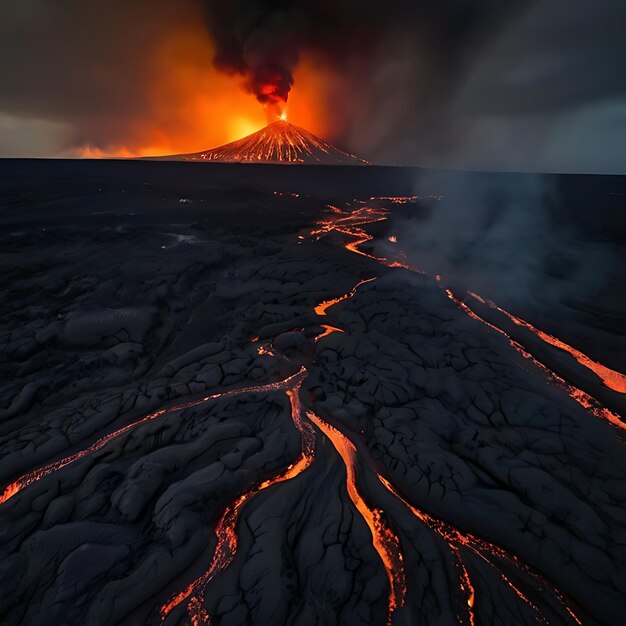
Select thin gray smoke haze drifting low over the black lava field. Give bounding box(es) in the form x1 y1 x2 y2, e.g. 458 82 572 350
381 171 619 310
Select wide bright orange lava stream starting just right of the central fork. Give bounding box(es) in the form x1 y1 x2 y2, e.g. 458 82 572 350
307 411 406 625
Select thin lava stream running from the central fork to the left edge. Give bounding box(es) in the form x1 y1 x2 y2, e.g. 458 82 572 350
0 368 305 504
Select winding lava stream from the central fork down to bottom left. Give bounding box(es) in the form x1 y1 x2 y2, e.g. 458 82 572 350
160 368 315 623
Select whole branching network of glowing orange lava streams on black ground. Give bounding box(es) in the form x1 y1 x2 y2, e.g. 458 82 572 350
7 193 612 626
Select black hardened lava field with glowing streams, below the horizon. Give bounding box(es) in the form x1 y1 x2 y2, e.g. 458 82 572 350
0 161 626 626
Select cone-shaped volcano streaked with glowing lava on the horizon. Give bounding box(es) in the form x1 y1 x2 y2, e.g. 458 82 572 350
167 121 369 165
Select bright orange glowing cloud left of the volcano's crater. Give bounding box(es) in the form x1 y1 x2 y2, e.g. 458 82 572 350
76 26 266 158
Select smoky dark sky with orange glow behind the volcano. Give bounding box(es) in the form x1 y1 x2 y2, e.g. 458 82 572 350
0 0 626 174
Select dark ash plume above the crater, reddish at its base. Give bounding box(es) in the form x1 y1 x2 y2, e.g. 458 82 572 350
206 0 528 116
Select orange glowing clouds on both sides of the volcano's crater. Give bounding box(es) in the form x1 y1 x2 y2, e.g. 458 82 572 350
73 24 333 158
